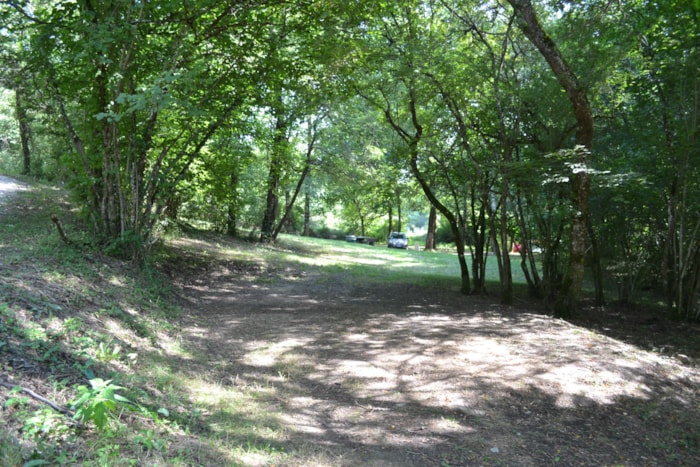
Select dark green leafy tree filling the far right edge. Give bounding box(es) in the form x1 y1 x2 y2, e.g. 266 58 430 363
618 1 700 319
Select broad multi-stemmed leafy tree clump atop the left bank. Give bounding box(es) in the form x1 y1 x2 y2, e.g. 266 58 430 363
10 0 268 260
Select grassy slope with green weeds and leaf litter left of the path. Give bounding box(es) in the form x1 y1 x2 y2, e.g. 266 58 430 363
0 184 189 465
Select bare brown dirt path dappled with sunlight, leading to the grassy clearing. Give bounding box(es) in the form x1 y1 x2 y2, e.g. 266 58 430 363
167 245 700 466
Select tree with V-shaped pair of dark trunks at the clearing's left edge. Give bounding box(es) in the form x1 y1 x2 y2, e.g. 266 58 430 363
254 4 348 242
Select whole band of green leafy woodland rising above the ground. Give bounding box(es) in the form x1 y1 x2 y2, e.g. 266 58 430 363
0 0 700 319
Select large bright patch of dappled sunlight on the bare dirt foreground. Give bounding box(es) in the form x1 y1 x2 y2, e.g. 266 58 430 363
270 315 662 416
